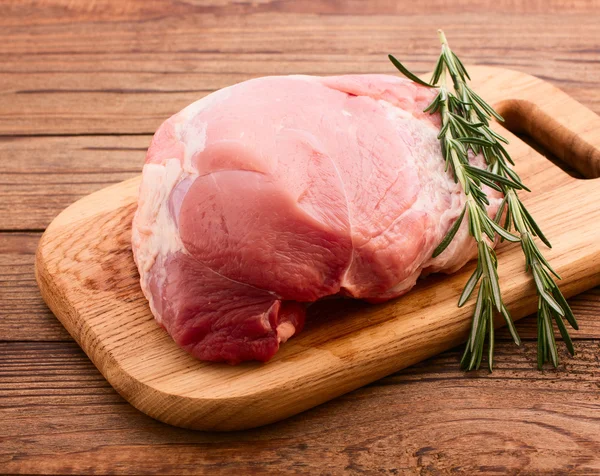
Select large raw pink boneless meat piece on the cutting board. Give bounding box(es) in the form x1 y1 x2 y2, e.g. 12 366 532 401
132 75 499 364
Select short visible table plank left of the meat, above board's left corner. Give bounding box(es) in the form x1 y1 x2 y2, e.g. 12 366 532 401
0 135 145 230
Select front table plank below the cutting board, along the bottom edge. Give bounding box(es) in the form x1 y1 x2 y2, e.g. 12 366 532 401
0 340 600 474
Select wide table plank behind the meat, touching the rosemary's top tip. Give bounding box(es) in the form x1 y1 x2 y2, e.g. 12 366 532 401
0 11 600 135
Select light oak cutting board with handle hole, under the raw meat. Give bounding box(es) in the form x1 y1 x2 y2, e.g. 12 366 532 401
36 67 600 430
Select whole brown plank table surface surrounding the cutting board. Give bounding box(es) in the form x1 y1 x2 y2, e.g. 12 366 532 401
0 0 600 474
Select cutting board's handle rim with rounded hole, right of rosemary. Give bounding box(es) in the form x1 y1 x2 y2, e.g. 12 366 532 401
493 70 600 179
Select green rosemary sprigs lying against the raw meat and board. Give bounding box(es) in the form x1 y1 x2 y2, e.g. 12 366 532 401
389 30 578 372
